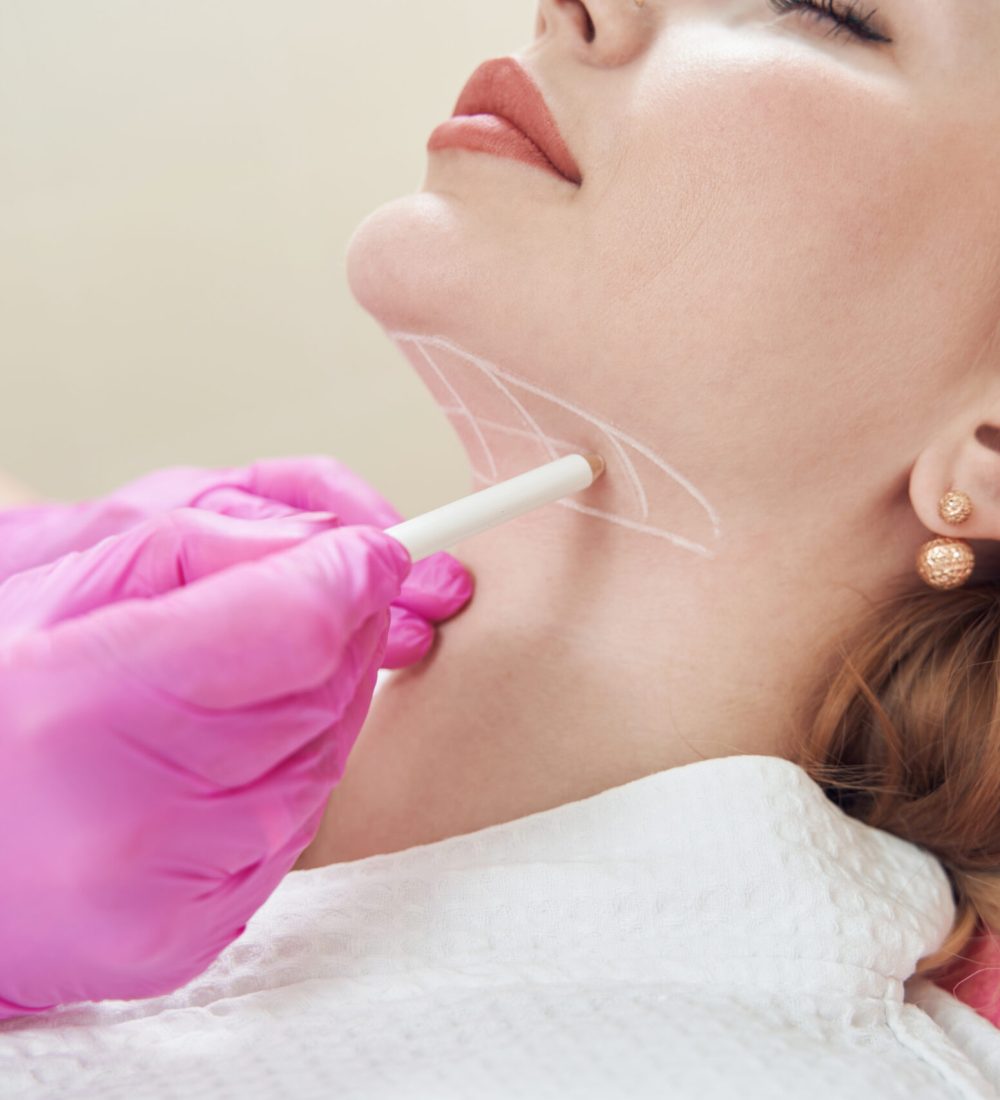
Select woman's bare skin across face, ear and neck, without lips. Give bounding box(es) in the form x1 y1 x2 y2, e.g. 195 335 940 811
288 0 1000 867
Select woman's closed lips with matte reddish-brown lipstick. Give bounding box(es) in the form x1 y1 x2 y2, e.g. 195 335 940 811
427 57 582 186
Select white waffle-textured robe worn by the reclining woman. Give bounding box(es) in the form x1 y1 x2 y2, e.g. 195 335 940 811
0 668 1000 1100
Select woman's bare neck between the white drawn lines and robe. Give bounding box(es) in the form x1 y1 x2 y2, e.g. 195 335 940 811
296 497 856 868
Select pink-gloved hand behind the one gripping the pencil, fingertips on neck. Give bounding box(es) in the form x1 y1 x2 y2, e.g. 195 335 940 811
0 455 470 669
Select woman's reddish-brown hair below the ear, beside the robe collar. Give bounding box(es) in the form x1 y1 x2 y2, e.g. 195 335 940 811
795 583 1000 1025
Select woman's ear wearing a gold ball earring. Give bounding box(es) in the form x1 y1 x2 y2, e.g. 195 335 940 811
910 418 1000 540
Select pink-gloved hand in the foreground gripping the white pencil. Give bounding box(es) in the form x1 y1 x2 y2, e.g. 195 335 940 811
0 508 471 1018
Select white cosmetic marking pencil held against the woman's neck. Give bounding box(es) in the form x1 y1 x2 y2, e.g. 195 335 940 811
385 454 604 562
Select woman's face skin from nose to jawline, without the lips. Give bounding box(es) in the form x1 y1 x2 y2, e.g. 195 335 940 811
349 0 1000 554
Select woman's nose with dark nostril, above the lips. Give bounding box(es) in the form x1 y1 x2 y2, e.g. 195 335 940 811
535 0 655 65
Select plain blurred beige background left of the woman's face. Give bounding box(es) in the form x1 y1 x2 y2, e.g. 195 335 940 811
0 0 535 515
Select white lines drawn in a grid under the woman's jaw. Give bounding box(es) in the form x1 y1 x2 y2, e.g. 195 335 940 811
387 332 722 558
